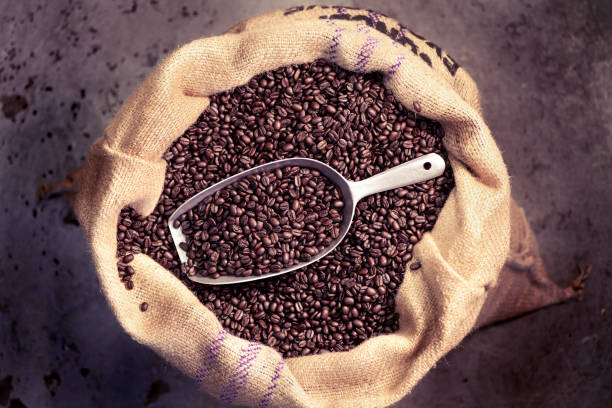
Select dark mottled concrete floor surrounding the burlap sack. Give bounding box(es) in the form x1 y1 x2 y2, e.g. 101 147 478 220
0 0 612 408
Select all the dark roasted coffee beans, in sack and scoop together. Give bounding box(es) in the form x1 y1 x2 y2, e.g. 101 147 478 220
117 61 453 357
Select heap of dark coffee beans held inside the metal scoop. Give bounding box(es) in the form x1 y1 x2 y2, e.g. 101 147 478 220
174 166 344 278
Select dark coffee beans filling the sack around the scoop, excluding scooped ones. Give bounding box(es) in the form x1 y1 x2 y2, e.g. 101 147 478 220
117 61 453 357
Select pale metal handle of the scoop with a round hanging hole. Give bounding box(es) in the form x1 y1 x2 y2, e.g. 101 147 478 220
349 153 446 203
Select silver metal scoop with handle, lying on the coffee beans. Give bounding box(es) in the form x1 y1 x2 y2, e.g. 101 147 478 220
168 153 445 285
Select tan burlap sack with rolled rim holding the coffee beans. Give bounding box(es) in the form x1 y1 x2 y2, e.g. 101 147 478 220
69 7 571 407
